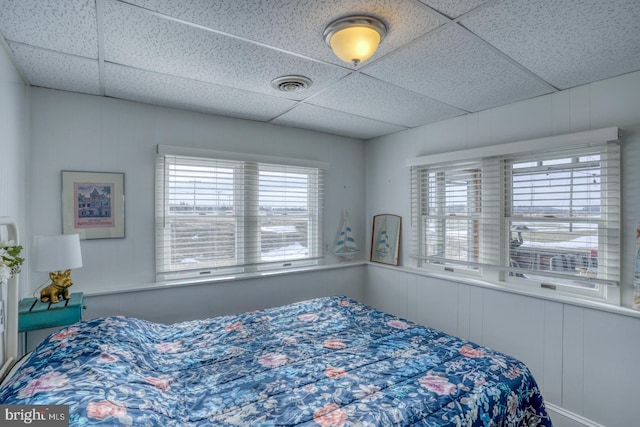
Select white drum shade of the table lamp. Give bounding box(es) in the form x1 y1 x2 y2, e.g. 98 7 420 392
34 234 82 271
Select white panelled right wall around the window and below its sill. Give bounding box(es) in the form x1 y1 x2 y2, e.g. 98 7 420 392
364 72 640 427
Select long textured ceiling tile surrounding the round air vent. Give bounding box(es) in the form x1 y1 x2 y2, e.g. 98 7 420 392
104 1 349 99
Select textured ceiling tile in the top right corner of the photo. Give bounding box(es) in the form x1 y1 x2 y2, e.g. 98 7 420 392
462 0 640 89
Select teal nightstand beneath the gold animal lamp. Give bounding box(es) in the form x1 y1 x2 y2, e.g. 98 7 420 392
18 292 83 334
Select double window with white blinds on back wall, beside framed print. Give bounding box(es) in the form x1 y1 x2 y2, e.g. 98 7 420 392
156 146 323 280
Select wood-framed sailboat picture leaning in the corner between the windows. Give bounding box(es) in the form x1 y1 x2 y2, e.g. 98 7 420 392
370 214 402 265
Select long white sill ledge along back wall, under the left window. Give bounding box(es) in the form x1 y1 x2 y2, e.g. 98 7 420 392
84 261 367 297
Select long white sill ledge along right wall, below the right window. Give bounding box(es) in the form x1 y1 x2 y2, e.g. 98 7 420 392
367 262 640 318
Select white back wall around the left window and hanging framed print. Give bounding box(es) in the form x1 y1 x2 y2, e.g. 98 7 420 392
29 88 365 293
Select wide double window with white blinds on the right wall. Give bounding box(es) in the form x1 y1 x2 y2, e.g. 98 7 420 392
409 128 620 302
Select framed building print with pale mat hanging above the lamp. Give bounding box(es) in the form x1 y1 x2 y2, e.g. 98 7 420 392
62 171 125 240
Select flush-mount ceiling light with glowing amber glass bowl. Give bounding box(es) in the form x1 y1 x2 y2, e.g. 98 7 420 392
324 15 387 67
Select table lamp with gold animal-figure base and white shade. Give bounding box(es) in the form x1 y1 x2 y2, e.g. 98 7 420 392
34 234 82 303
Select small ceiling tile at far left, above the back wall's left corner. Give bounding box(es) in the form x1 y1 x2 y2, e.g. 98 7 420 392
9 43 100 95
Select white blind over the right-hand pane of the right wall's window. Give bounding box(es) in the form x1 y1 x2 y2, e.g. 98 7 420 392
504 144 620 287
